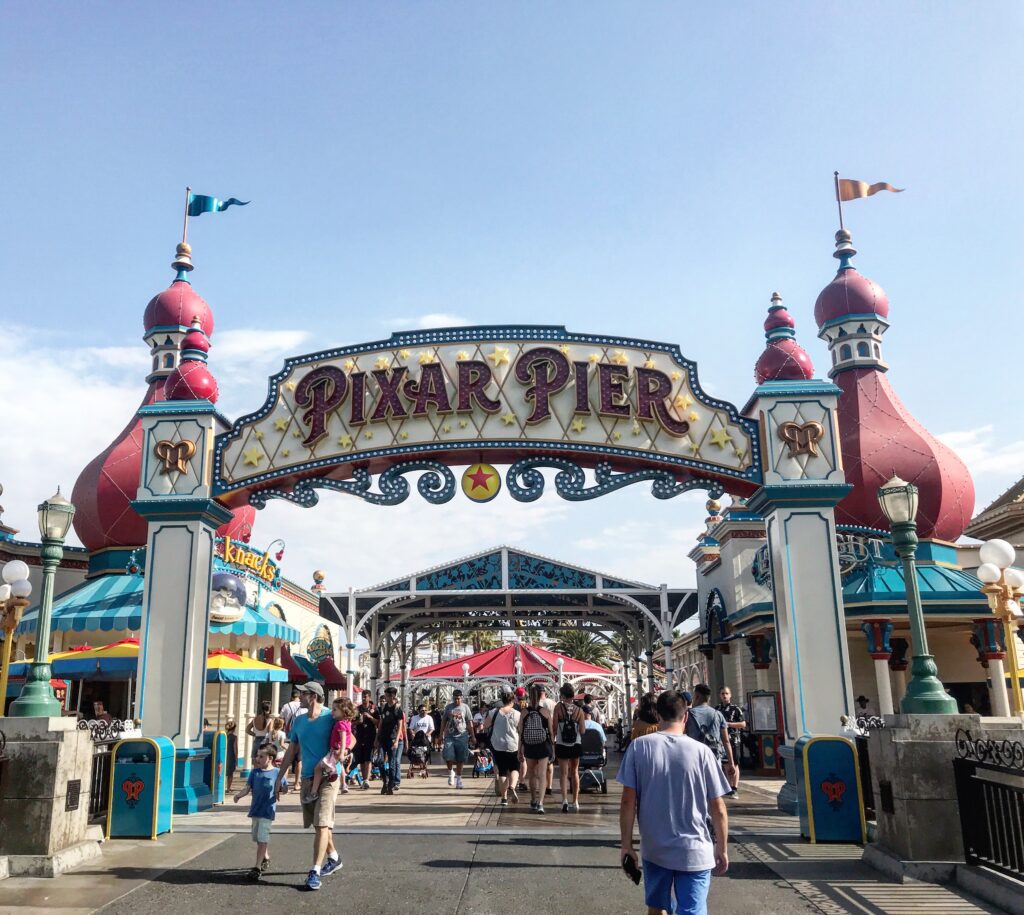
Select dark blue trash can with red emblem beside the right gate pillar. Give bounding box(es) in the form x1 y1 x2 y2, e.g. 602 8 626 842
794 735 867 844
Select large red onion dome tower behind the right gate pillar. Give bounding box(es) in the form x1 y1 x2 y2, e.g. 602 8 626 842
814 229 974 541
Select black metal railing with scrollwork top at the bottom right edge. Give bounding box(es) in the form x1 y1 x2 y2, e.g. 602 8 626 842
953 731 1024 880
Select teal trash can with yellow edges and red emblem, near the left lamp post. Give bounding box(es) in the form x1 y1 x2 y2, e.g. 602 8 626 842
106 737 174 839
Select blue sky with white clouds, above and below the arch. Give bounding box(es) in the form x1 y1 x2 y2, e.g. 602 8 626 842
0 2 1024 610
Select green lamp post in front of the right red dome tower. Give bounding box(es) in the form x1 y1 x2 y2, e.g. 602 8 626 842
879 476 956 714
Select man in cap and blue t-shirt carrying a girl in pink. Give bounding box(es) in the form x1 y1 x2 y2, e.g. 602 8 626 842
276 681 341 889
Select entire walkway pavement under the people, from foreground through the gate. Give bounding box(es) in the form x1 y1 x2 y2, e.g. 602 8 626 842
0 769 997 915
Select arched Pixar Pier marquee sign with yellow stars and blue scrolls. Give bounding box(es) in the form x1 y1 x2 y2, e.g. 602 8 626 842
214 326 761 507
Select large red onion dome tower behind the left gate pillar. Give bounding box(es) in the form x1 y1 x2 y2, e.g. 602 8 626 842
72 244 256 567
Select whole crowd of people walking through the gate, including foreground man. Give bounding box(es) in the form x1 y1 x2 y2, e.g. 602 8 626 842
234 682 745 912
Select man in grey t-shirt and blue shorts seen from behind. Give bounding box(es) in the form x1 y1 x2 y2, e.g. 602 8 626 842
616 690 729 912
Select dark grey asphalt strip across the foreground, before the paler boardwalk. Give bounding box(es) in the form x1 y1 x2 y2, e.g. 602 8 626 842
99 834 819 915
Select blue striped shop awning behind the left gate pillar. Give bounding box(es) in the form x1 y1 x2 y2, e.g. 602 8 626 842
14 575 301 643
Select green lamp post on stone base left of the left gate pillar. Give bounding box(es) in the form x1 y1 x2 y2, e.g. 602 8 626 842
10 489 75 717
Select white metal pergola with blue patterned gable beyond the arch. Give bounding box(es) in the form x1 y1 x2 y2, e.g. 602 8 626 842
319 546 697 707
